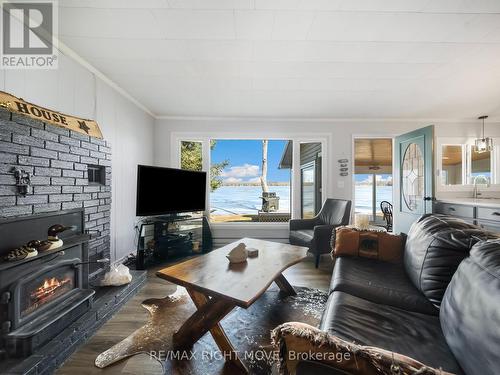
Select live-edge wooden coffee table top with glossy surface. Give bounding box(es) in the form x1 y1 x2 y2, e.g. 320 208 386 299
156 238 307 308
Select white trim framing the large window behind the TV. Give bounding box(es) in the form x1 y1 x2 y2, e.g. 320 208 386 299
170 132 332 229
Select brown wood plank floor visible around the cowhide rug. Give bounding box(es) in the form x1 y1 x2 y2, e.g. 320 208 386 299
57 255 333 375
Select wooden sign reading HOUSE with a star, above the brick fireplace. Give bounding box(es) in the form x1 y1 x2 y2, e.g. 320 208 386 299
0 91 102 139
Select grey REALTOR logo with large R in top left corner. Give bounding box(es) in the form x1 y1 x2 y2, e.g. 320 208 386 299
1 0 57 69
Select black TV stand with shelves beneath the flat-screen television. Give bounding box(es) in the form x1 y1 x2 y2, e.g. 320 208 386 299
136 214 208 270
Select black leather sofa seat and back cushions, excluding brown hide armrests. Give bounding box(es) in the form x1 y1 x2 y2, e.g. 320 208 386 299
297 215 500 375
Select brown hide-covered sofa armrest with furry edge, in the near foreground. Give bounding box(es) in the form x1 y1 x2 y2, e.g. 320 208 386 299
271 322 451 375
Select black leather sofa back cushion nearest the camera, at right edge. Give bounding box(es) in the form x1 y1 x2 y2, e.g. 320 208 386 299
439 240 500 375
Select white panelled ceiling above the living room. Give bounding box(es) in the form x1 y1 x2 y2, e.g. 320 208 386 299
59 0 500 119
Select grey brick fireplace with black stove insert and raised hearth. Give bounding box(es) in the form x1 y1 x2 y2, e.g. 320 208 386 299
0 108 146 375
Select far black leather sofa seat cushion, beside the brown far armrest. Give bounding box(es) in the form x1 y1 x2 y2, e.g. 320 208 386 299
330 257 439 315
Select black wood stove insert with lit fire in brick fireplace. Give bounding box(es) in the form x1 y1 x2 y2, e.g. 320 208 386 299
0 210 95 357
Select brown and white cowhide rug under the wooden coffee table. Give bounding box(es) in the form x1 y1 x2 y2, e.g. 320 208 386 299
95 287 328 374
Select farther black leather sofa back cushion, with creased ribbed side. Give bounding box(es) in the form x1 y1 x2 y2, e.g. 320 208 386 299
404 214 497 308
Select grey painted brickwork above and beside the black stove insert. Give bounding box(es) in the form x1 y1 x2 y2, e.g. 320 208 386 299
0 108 111 275
